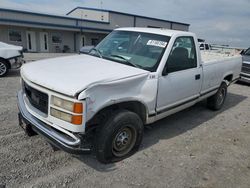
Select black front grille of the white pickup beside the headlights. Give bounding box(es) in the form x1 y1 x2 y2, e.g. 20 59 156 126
23 82 49 114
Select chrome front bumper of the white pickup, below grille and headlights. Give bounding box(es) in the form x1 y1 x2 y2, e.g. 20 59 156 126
17 91 91 154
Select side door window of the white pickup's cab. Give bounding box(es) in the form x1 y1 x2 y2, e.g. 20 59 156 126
165 37 197 73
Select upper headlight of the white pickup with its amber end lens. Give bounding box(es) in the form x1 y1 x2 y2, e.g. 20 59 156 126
52 96 83 113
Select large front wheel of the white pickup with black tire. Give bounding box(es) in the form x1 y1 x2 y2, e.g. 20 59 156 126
95 110 144 163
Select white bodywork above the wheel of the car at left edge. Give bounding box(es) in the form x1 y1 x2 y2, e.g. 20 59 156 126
0 42 23 59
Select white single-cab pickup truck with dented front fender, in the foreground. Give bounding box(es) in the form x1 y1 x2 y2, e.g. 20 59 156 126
18 28 242 163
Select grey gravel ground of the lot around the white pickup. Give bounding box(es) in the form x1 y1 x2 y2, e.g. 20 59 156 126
0 53 250 188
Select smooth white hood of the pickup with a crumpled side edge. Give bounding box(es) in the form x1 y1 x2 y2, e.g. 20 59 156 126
21 55 149 96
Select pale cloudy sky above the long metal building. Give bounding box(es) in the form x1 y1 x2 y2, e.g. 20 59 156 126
0 0 250 47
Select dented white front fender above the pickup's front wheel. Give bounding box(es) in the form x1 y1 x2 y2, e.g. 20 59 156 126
78 73 157 121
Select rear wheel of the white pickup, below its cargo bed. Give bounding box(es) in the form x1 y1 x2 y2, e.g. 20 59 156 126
207 82 227 111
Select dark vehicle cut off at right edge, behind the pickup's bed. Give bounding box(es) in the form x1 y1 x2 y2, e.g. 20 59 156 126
240 48 250 83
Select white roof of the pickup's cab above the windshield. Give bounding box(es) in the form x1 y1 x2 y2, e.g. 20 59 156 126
115 27 193 36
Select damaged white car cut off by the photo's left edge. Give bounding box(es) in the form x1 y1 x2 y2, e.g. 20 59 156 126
0 42 24 77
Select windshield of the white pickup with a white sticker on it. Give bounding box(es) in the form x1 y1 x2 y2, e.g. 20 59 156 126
89 31 170 72
